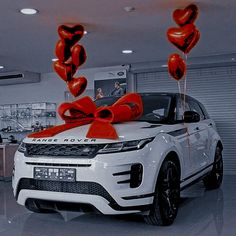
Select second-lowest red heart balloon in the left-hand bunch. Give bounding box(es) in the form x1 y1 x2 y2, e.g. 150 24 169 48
53 61 76 81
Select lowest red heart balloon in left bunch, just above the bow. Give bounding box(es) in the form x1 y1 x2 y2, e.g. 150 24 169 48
67 76 87 97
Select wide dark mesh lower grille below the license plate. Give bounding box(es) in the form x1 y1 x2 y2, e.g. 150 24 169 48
17 178 115 203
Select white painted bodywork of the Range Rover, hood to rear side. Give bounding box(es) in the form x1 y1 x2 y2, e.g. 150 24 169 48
13 93 220 214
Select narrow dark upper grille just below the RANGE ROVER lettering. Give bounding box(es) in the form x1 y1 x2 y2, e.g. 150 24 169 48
25 143 104 158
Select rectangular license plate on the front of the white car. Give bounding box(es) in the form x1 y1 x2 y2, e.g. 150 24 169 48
34 167 76 182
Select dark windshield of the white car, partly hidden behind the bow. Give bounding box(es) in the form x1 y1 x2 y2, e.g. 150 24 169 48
95 95 171 123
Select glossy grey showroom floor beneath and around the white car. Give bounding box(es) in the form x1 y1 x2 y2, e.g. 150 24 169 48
0 176 236 236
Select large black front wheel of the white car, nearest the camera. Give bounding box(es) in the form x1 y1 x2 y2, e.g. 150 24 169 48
144 159 180 226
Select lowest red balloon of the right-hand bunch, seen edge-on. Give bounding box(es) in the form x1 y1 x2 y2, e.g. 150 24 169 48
168 53 186 81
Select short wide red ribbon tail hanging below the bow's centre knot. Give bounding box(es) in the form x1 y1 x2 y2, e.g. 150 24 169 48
86 120 119 139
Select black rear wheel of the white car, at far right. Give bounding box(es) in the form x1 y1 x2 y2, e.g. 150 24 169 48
203 146 223 189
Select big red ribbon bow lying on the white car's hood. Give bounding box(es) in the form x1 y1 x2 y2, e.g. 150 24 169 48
28 93 143 139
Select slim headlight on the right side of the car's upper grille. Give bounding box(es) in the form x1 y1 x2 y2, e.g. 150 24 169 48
98 138 154 153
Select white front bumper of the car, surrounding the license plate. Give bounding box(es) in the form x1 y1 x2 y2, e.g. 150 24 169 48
13 148 157 214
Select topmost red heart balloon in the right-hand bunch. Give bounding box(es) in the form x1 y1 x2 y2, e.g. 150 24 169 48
173 4 198 26
